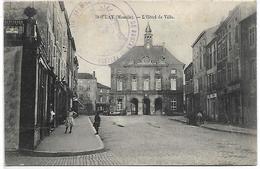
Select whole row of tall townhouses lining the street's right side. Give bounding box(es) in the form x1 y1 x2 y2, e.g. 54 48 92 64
184 2 256 127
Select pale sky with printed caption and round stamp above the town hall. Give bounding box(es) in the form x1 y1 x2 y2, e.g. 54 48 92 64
65 0 246 86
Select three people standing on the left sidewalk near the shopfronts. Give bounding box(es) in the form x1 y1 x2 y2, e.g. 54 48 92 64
50 107 101 134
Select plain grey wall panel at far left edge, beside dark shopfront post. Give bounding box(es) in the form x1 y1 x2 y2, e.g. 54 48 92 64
4 46 23 150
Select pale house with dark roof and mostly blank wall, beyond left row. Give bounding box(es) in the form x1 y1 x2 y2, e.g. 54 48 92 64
78 72 97 115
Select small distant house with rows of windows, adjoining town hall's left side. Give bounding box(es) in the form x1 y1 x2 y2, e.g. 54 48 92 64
96 83 111 113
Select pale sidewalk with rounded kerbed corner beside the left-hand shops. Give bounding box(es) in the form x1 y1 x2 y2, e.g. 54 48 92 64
19 115 104 156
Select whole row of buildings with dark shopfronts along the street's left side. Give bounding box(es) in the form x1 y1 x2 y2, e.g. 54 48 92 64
4 1 79 150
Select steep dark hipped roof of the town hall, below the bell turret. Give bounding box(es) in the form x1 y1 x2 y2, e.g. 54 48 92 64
109 46 184 66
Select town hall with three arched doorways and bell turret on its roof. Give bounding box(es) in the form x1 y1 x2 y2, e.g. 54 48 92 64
109 24 184 115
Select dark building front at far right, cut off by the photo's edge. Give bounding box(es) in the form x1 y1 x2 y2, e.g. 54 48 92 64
240 13 257 128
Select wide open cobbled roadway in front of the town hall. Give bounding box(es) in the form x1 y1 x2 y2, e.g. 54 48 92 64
6 116 257 165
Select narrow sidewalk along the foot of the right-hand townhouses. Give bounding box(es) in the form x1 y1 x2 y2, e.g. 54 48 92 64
169 116 257 136
